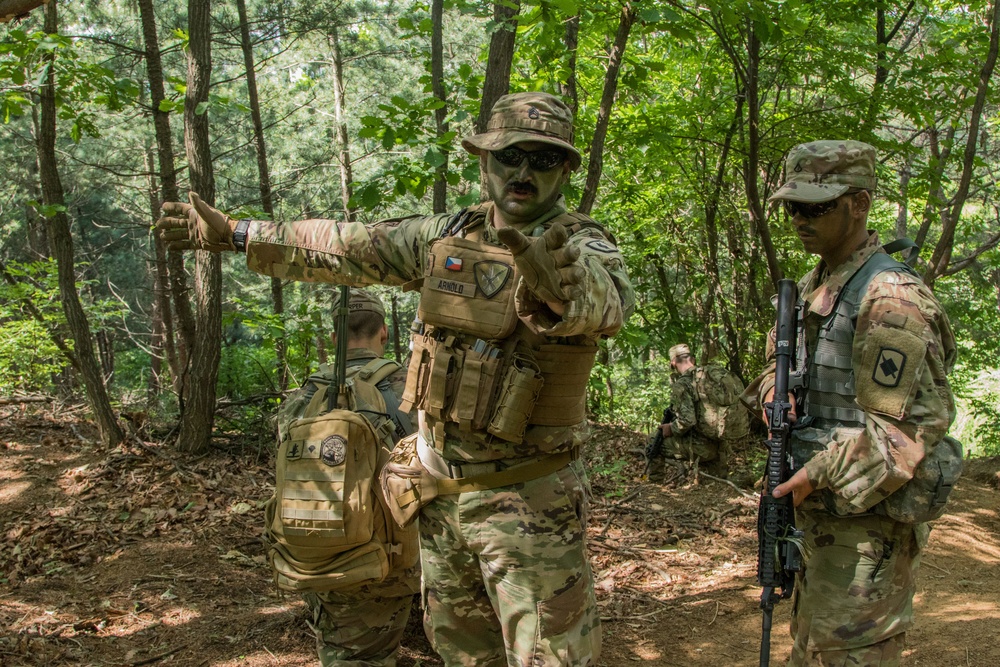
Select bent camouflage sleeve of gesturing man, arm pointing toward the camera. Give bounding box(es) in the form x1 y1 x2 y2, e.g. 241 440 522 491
517 228 635 338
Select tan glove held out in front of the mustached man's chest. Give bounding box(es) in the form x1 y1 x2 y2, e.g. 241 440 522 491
497 222 586 303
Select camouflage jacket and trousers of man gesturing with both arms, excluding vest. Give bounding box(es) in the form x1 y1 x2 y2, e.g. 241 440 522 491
247 200 633 666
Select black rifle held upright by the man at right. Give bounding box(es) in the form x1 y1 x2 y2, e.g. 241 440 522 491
757 280 802 667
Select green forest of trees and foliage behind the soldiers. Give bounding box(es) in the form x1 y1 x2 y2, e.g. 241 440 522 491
0 0 1000 454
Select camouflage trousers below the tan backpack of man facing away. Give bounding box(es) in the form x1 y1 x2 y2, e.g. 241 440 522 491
303 568 419 667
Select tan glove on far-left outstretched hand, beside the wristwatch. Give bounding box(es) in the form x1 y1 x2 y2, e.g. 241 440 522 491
156 192 238 252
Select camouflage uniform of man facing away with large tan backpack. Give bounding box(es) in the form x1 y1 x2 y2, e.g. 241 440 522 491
278 348 420 667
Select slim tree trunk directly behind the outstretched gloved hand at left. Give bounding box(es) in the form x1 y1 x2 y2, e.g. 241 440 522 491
138 0 194 394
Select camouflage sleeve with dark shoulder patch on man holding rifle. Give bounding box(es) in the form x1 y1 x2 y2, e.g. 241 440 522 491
805 273 956 510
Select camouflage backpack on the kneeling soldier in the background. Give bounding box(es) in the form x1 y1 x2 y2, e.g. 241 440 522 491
694 364 750 440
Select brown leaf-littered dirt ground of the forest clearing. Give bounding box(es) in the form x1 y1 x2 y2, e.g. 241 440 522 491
0 406 1000 667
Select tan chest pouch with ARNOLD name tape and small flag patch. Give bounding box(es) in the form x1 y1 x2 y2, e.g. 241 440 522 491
417 236 518 340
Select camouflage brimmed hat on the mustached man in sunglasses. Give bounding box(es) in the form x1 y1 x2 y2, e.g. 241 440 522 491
462 93 581 169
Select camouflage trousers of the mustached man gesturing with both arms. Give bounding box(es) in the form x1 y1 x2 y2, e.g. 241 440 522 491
420 461 601 667
